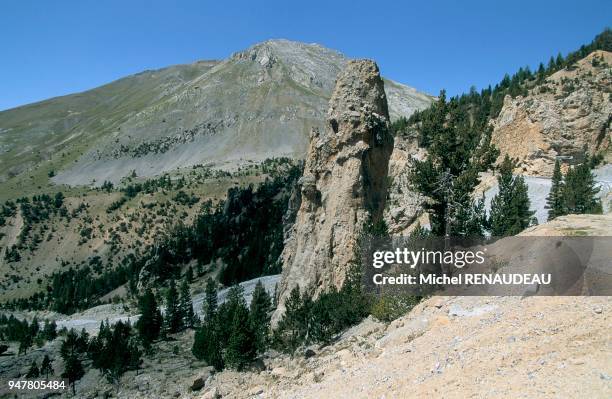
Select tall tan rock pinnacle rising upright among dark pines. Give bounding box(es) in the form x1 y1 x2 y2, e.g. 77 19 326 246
275 60 393 319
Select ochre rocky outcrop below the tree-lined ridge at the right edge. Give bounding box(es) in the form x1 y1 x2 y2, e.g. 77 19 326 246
492 51 612 176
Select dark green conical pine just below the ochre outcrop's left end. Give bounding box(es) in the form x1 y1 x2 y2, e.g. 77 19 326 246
490 154 534 237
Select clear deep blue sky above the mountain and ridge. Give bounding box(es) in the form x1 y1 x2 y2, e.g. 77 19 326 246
0 0 612 110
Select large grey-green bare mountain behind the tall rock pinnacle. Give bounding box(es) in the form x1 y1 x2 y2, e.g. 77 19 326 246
0 40 432 189
